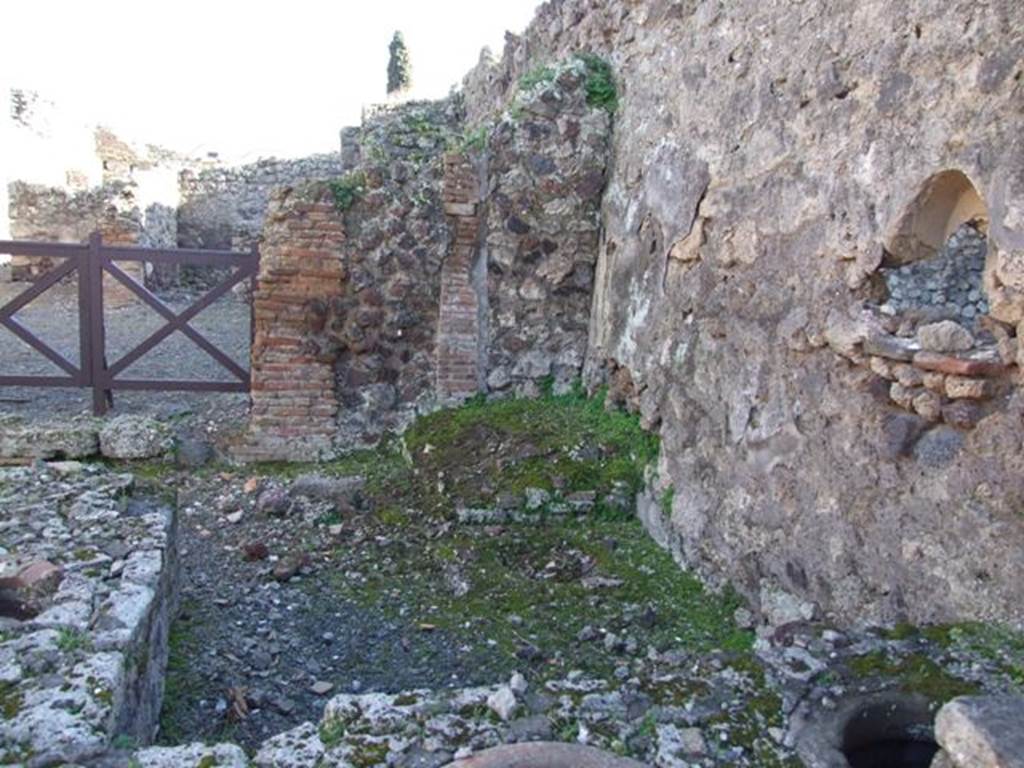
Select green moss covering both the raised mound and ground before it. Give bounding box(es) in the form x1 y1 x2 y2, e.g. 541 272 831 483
301 389 756 688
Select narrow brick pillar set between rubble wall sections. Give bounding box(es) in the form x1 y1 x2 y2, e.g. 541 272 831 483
437 153 482 400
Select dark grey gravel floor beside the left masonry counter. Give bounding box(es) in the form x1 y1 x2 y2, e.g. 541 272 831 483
161 474 544 748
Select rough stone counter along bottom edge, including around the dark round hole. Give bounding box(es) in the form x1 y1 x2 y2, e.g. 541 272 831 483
134 622 1024 768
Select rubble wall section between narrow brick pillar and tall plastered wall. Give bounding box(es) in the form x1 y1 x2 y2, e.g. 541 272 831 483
484 59 610 393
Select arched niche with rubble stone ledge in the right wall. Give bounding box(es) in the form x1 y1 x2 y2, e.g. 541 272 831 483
825 169 1017 442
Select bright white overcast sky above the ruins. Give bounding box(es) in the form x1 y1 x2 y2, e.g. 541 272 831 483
0 0 540 158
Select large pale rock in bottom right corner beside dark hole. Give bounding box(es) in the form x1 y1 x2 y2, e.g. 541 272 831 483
935 695 1024 768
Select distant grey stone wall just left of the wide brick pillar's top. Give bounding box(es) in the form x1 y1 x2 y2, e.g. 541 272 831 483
178 153 343 249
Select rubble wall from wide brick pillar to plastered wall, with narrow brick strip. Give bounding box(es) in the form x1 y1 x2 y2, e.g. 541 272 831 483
240 79 610 457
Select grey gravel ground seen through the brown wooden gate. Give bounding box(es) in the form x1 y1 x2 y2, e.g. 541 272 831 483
0 279 249 433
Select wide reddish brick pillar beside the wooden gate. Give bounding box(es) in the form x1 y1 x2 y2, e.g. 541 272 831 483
234 188 346 461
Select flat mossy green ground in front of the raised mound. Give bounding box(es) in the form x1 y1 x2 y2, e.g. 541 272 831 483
321 518 753 677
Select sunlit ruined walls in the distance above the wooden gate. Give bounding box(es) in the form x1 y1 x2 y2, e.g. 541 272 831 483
0 89 342 288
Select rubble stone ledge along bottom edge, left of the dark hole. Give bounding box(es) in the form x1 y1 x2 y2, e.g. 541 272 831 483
134 649 788 768
